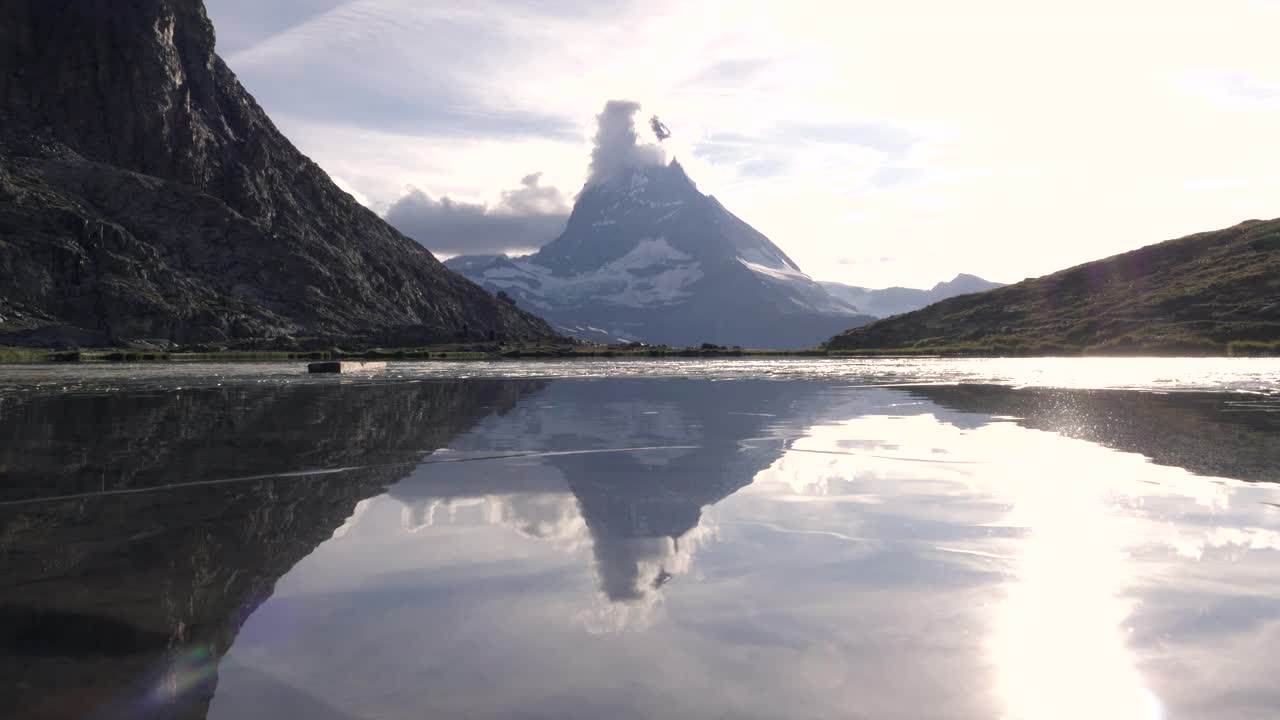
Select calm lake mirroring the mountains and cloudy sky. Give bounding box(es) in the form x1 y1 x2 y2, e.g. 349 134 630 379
0 359 1280 720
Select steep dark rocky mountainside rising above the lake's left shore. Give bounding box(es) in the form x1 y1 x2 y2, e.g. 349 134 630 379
0 0 554 345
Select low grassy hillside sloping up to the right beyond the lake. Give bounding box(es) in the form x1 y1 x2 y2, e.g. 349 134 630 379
827 219 1280 355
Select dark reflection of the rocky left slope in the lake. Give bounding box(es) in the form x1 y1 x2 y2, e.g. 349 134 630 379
0 380 544 720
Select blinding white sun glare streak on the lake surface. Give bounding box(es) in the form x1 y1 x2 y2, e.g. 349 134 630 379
991 430 1165 720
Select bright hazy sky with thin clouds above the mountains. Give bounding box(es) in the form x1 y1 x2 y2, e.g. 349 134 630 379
206 0 1280 287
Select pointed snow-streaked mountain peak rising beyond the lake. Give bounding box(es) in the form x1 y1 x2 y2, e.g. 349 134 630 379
445 161 870 348
